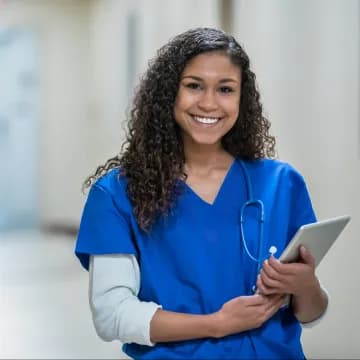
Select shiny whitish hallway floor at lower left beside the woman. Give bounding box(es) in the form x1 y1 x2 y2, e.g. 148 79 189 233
0 232 127 359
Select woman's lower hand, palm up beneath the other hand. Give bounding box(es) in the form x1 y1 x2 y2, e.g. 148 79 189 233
214 294 286 338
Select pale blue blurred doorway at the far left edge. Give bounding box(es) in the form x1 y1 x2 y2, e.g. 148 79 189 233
0 27 39 231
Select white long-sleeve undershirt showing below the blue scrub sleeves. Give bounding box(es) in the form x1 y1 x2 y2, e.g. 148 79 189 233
89 254 329 346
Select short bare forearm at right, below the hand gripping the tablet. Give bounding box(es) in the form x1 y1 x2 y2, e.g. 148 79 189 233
292 282 328 323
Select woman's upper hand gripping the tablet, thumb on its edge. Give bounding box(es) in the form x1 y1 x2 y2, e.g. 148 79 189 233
256 246 319 296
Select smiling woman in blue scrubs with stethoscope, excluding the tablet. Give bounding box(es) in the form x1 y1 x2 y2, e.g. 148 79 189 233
76 28 327 359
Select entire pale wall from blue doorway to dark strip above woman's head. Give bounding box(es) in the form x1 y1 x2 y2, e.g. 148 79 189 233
0 0 218 228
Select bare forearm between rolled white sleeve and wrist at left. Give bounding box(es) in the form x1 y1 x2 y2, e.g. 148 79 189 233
150 309 217 343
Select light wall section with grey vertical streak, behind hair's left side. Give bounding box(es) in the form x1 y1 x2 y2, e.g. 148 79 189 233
88 0 218 170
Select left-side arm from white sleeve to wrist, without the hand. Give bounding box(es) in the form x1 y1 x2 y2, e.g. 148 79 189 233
89 254 216 346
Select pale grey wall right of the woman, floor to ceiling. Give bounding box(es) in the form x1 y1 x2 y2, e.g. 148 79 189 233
234 0 360 359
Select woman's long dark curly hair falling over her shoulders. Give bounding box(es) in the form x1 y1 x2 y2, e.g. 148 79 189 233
84 28 275 231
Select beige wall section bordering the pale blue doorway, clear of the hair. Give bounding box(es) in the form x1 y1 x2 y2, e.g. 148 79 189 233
0 0 91 228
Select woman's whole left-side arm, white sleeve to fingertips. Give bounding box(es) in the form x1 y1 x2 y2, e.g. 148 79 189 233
89 254 283 346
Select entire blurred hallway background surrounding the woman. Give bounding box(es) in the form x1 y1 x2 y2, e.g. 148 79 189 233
0 0 360 359
